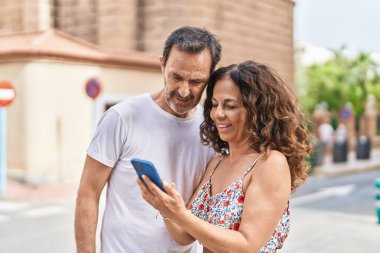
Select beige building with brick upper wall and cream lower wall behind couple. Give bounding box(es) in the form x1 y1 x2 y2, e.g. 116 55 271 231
0 0 294 184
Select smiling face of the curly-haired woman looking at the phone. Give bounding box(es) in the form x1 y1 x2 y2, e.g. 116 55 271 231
210 77 247 143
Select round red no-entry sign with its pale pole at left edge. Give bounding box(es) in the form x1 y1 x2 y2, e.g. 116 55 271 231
0 81 16 195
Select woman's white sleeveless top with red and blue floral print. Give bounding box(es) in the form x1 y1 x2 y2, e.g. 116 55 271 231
189 155 290 253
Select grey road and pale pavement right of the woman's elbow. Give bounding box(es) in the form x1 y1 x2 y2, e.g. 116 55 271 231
280 170 380 253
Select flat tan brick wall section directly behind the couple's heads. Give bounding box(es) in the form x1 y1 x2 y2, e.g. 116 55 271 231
130 0 294 85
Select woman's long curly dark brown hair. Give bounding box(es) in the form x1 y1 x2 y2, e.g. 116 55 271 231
201 61 311 190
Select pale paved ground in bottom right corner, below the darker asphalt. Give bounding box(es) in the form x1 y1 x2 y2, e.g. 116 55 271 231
280 208 380 253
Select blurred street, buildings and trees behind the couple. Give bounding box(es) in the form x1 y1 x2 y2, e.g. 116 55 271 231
0 0 380 253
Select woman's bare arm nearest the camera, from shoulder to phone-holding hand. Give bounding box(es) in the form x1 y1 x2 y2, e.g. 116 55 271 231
139 152 290 252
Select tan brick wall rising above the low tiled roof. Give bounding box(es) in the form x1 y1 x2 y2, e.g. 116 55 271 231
0 0 294 85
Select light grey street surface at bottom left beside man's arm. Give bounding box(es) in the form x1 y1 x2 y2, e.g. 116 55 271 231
0 199 75 253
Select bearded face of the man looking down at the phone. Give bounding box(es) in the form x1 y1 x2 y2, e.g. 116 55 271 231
161 47 211 117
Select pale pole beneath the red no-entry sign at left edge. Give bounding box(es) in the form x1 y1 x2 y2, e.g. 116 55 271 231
0 106 7 195
